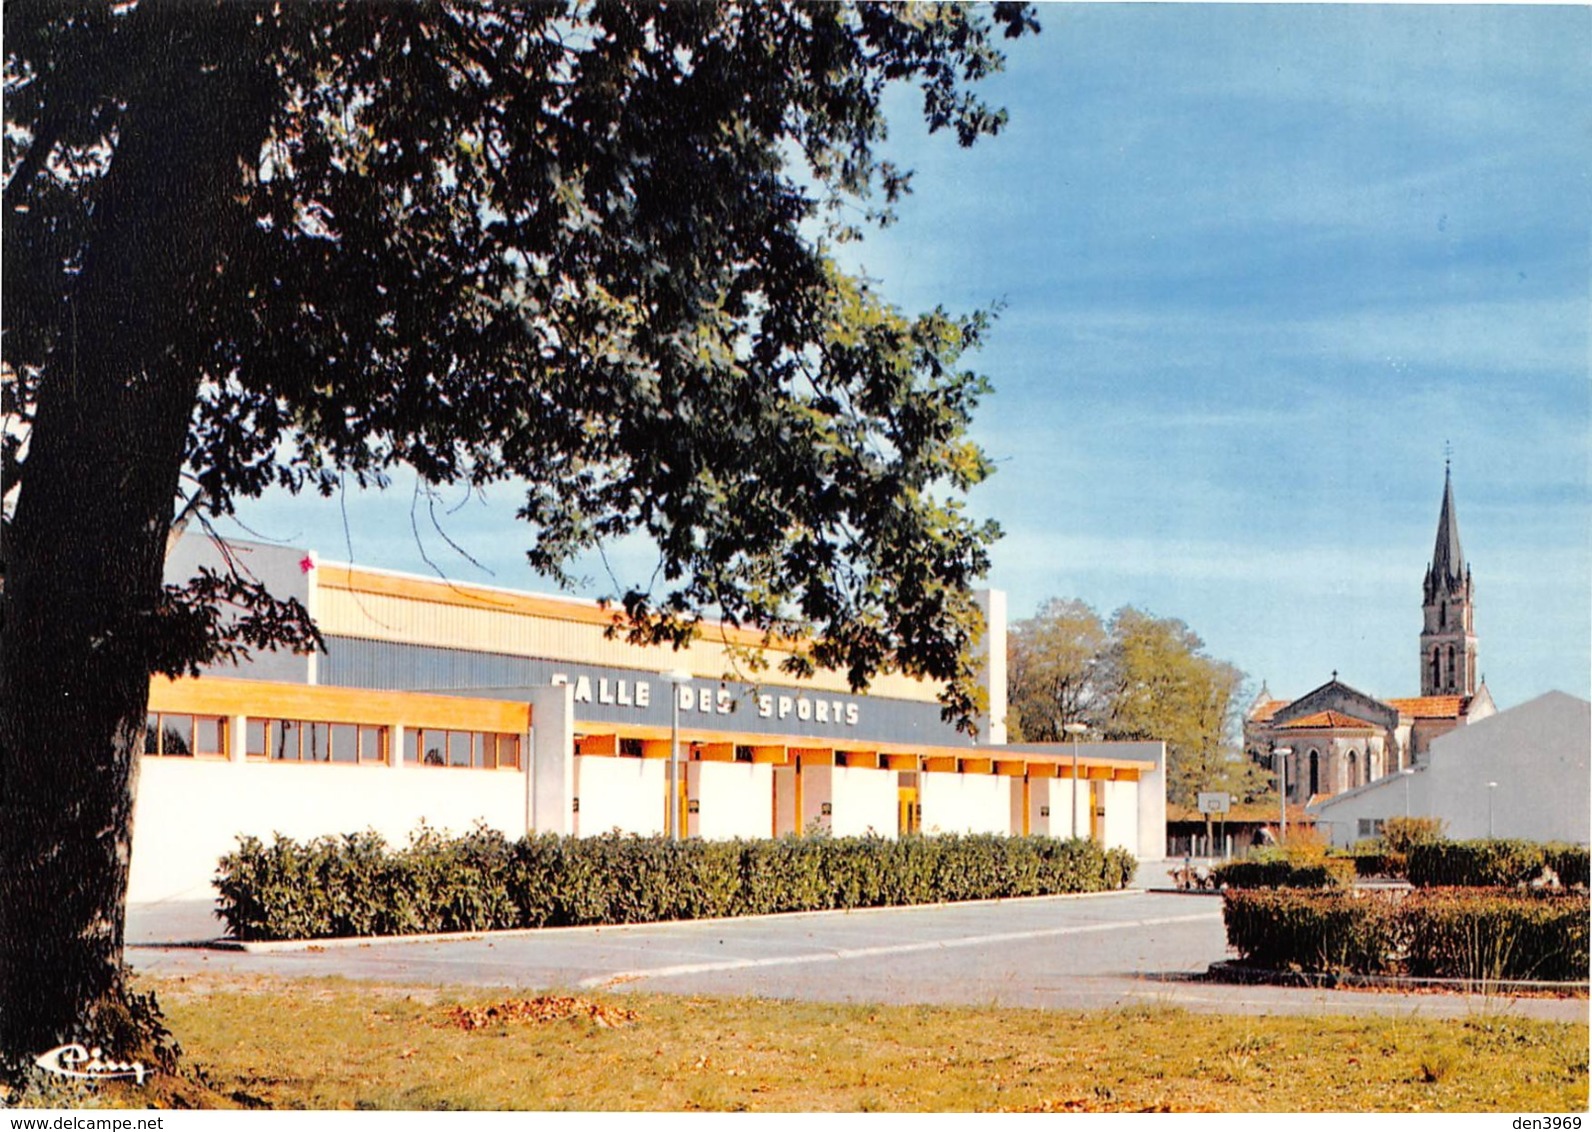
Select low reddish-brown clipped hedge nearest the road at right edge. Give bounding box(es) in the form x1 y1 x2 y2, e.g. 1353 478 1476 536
1223 888 1589 982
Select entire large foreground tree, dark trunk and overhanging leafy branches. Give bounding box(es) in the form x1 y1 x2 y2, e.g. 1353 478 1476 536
0 0 1036 1065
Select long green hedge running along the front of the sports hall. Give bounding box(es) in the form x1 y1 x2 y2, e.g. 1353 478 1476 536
215 828 1137 941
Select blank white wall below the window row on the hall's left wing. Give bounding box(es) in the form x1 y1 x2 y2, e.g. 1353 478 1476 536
127 758 525 903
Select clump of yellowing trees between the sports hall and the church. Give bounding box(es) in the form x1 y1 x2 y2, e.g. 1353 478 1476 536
1006 599 1264 806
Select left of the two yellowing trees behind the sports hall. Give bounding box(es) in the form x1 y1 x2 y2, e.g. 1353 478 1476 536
1006 597 1108 744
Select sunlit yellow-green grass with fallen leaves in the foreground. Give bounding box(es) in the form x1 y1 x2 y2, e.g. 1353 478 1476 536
56 978 1587 1113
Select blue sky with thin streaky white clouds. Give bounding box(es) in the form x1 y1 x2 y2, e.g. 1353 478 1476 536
221 3 1592 707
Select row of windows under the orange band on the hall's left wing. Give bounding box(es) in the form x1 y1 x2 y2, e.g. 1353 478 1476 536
143 712 521 771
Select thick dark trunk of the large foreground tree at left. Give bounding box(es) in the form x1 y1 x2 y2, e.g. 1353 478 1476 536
0 5 263 1067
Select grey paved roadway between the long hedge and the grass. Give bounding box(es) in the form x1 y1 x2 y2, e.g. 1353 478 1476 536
127 892 1587 1022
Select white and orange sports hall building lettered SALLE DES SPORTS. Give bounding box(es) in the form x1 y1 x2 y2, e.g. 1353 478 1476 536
129 538 1165 901
